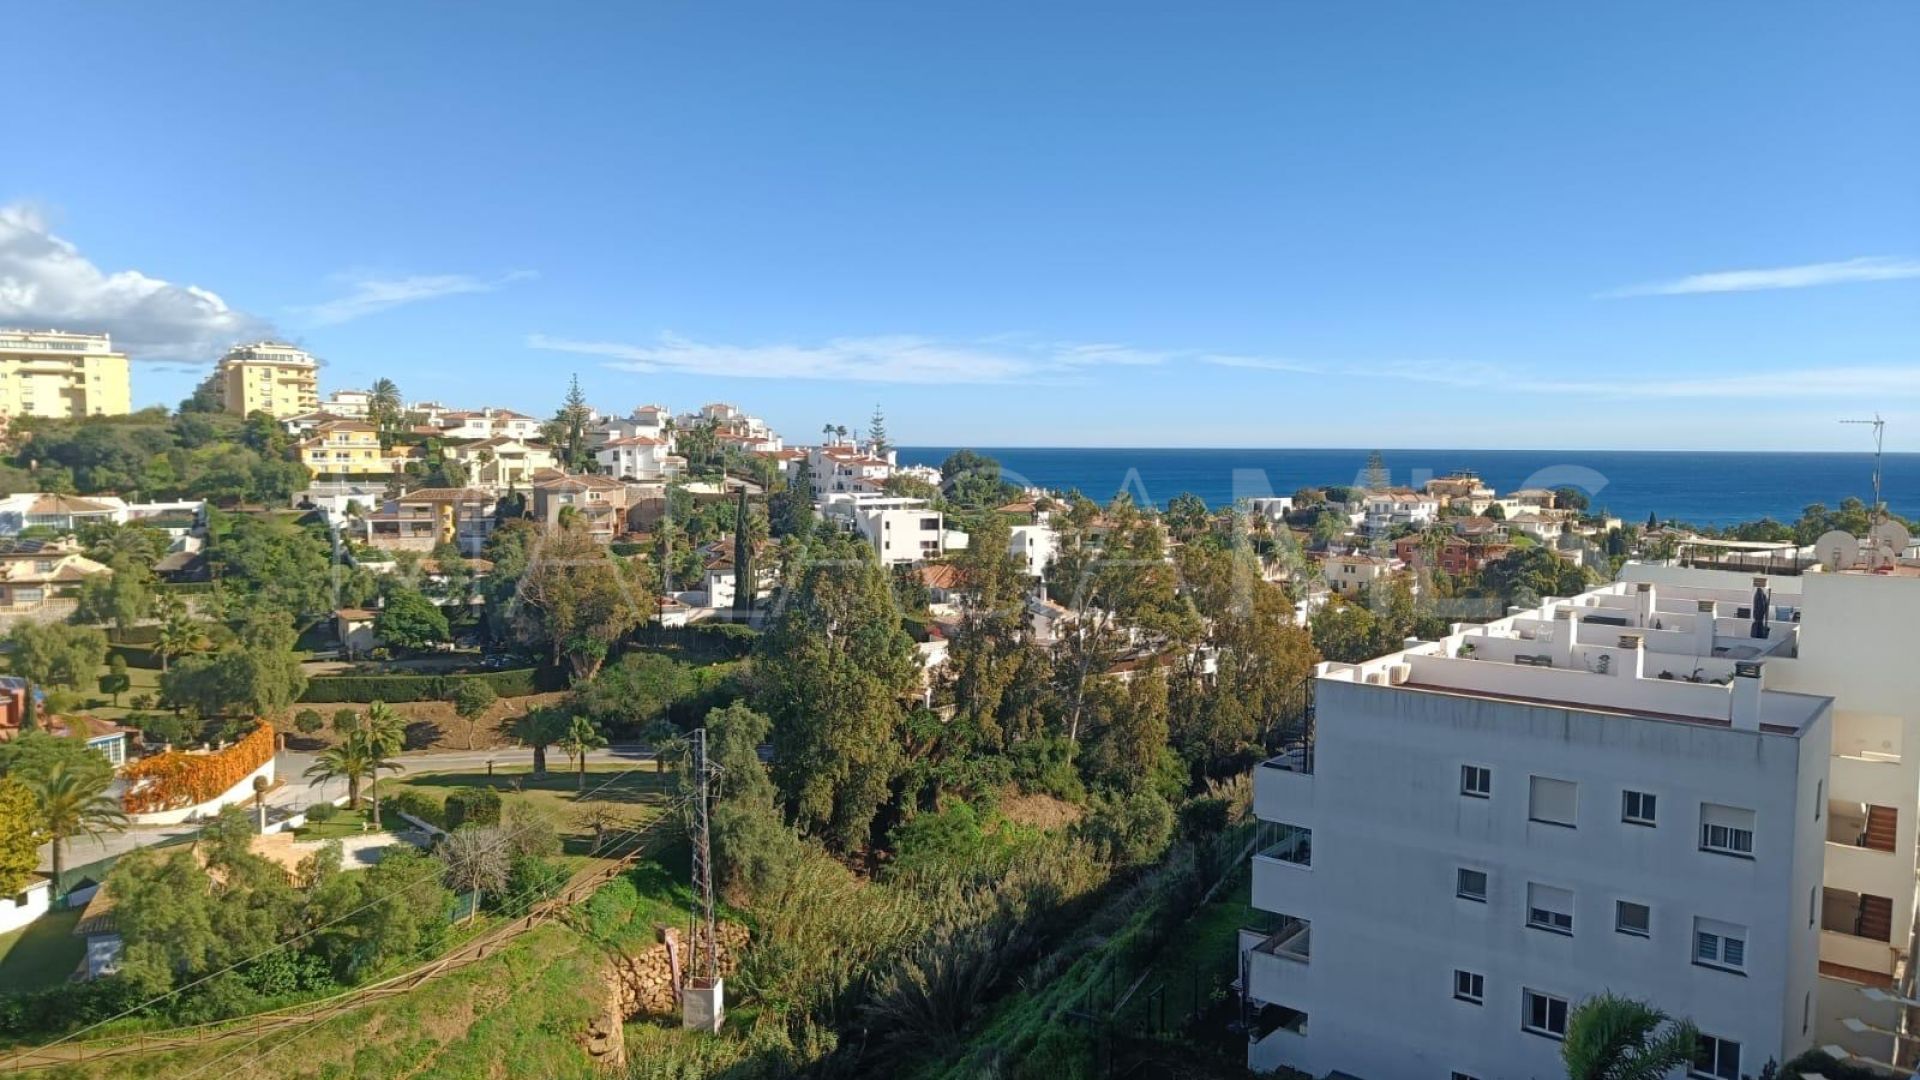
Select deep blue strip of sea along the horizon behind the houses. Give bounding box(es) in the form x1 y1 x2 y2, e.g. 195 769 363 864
899 446 1920 527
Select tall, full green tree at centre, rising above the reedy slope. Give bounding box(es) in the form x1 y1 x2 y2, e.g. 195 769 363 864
755 538 920 851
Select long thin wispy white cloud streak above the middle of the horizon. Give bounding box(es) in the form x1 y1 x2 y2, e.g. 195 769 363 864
526 334 1171 384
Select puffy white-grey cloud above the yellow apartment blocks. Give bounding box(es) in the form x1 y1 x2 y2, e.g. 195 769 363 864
0 204 273 361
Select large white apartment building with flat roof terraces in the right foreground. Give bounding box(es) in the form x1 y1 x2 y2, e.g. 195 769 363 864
1240 584 1827 1080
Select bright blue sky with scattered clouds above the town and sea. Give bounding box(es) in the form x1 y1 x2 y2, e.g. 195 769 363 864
0 0 1920 450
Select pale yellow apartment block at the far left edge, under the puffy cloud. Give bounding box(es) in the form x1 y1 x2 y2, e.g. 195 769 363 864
0 331 132 419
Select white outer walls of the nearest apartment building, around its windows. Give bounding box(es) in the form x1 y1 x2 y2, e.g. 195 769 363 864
1252 669 1830 1080
